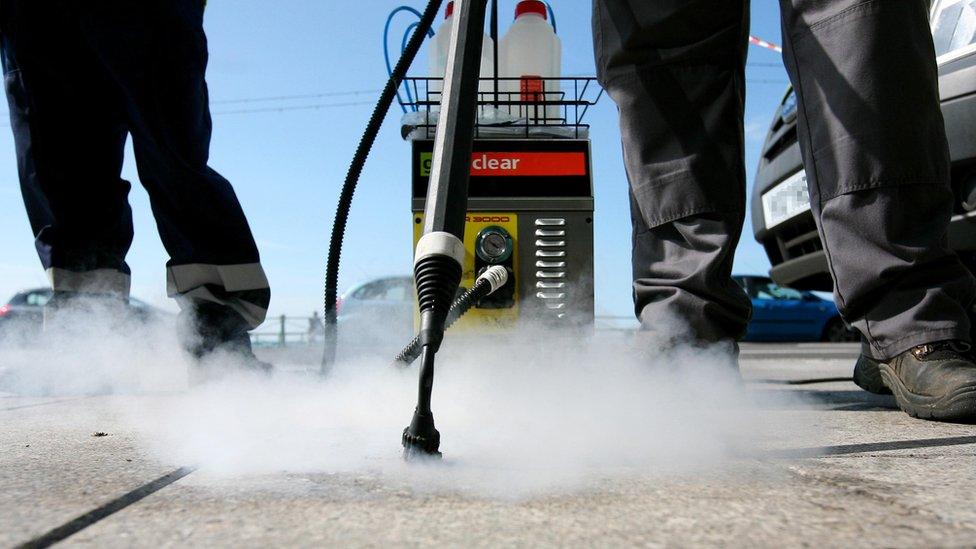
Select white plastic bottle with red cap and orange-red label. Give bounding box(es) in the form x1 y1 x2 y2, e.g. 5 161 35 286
498 0 563 124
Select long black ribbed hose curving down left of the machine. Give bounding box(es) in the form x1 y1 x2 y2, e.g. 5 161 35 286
322 0 442 373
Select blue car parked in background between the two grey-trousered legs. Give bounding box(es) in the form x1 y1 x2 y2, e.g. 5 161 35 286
732 276 860 342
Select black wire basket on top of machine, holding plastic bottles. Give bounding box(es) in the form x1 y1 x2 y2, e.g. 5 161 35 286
402 77 603 139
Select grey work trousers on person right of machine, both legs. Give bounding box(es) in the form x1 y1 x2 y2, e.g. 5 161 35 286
593 0 976 359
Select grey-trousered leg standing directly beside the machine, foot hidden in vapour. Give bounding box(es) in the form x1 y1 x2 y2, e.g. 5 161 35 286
593 0 750 342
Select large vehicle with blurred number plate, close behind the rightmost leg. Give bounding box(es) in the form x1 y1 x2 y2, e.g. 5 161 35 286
752 0 976 291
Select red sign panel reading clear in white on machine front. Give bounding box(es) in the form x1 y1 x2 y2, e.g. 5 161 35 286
471 152 586 177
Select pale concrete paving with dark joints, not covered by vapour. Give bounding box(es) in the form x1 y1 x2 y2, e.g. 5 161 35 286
0 344 976 547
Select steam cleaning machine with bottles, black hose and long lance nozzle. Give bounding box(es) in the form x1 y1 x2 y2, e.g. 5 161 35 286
323 0 602 459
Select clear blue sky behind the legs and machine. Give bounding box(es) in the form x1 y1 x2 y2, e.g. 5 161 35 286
0 0 787 316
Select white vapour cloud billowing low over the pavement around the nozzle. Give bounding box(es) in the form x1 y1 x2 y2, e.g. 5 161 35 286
0 306 792 497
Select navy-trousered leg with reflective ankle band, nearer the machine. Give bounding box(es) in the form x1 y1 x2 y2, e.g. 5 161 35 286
72 0 271 364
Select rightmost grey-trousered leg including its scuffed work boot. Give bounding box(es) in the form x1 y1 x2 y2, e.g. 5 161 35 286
781 0 976 419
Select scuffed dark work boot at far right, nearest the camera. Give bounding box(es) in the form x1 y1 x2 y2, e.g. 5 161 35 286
879 341 976 423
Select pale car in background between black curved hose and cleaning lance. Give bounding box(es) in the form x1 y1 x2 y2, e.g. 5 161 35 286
336 276 416 358
